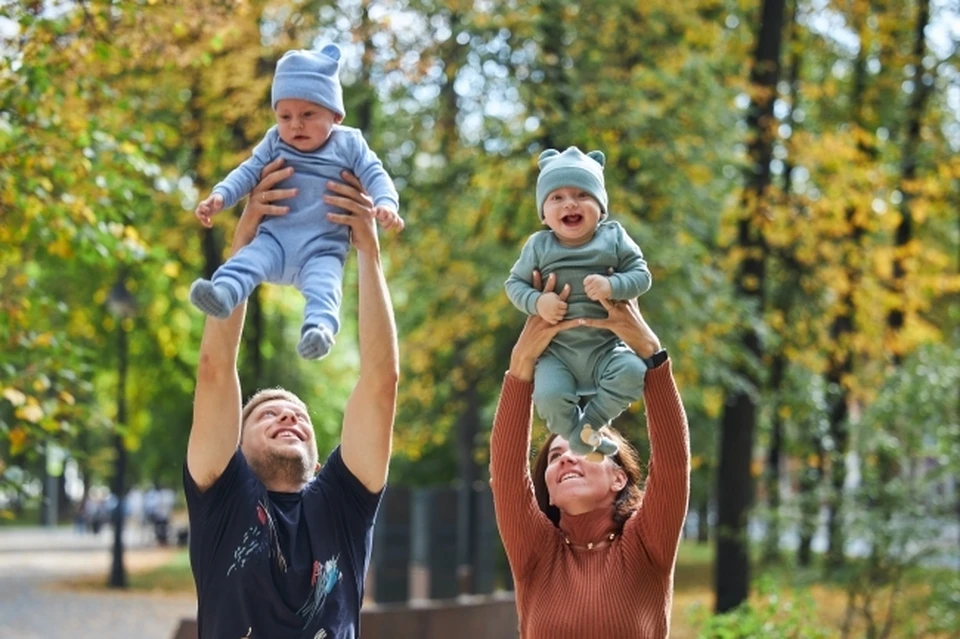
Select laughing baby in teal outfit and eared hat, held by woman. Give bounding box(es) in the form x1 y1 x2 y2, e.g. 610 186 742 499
506 147 651 460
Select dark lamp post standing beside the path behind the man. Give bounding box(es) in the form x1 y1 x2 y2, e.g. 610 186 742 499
107 272 136 588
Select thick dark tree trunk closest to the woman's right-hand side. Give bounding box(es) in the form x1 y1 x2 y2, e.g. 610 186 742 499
714 0 786 613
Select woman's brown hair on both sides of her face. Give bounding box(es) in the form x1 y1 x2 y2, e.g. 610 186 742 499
531 426 643 526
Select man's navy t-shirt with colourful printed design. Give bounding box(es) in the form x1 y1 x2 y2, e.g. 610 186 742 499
183 448 382 639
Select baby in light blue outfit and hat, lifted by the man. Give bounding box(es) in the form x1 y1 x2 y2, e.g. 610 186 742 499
190 44 403 359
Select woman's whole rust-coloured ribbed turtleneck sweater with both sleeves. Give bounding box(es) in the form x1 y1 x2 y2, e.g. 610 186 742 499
490 361 690 639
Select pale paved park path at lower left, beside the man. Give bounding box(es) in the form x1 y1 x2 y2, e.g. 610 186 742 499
0 528 196 639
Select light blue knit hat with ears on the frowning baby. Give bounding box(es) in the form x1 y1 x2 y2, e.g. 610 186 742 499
270 44 347 117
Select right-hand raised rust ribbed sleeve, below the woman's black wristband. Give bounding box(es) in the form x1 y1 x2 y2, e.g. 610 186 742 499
624 360 690 569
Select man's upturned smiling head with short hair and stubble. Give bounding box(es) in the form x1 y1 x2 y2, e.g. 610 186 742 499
240 394 317 492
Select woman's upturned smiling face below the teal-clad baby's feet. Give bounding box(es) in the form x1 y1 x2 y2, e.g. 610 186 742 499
543 437 627 515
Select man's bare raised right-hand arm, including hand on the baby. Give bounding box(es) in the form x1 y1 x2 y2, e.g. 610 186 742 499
325 173 400 492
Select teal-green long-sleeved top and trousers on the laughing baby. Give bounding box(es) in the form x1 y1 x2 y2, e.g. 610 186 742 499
506 221 651 454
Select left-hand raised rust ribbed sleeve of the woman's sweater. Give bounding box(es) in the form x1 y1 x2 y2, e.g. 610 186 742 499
490 373 556 581
